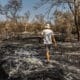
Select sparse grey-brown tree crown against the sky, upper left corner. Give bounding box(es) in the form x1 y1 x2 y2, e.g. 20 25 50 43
0 0 22 21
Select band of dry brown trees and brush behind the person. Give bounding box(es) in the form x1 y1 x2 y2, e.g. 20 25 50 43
0 0 80 41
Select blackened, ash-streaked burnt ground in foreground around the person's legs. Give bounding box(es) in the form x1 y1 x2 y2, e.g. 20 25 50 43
0 41 80 80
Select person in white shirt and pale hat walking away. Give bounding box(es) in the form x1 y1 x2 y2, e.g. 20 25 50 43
41 24 57 62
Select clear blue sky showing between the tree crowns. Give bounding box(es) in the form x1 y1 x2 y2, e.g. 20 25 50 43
0 0 69 19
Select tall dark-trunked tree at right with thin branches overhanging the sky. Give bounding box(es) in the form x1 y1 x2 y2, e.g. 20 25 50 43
35 0 80 40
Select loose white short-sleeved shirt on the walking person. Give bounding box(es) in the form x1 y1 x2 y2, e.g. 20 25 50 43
42 29 53 44
